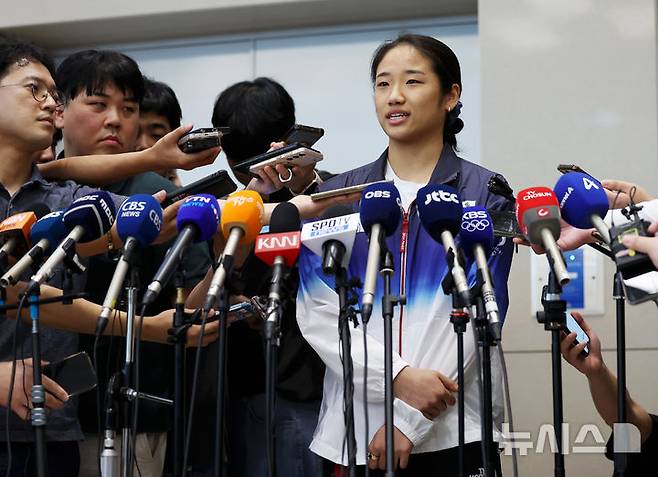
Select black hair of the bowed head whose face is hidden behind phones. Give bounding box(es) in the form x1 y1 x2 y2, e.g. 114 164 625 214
212 78 295 161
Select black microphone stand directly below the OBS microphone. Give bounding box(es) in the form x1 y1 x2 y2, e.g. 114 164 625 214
376 249 406 477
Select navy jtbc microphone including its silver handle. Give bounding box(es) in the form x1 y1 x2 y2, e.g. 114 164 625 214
416 184 471 306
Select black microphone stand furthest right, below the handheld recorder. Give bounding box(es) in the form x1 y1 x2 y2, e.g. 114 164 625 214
612 270 628 477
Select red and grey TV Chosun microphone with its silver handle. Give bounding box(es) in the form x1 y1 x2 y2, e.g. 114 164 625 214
516 187 571 285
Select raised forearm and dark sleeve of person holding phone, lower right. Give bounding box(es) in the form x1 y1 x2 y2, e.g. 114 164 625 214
560 312 658 477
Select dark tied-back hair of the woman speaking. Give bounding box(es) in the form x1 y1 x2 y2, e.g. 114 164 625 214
370 33 464 147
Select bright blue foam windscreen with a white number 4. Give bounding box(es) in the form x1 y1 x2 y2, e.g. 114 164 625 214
553 172 609 229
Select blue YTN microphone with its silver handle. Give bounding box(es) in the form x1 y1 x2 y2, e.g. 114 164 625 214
142 194 219 307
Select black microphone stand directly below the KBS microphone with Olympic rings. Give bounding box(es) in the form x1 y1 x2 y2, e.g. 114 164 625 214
471 270 496 477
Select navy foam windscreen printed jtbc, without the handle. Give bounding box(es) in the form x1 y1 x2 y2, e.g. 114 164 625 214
416 184 464 242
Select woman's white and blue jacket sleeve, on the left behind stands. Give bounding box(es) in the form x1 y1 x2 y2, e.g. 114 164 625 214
297 247 409 402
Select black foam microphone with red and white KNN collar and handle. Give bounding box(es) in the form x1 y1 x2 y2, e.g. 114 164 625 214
254 202 301 339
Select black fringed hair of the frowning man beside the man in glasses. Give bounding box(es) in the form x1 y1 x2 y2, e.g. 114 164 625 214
55 50 144 102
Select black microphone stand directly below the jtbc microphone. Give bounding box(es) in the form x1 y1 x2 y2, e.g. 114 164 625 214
441 249 469 477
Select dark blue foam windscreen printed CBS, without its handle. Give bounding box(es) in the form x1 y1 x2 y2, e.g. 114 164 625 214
117 194 162 247
